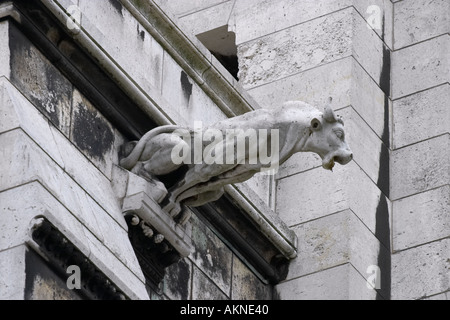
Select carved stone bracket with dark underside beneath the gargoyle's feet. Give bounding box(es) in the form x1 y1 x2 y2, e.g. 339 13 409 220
122 172 192 291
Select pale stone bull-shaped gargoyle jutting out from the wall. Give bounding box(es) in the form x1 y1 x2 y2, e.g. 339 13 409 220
120 98 353 224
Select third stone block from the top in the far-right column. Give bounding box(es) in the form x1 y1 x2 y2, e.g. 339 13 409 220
392 83 450 149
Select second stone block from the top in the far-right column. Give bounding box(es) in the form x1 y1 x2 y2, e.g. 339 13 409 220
391 34 450 99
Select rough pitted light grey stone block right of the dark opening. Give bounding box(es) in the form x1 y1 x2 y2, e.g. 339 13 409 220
238 9 353 89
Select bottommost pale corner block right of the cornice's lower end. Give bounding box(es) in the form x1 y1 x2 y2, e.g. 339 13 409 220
276 263 376 300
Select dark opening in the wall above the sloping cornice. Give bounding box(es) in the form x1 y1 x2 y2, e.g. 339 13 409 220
197 25 239 80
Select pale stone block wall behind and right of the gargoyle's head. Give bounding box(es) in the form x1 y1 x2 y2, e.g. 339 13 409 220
170 0 450 299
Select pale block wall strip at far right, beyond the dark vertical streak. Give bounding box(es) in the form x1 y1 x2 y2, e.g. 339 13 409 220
391 0 450 300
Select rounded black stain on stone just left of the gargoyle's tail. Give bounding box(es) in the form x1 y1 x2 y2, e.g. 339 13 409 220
72 99 114 160
